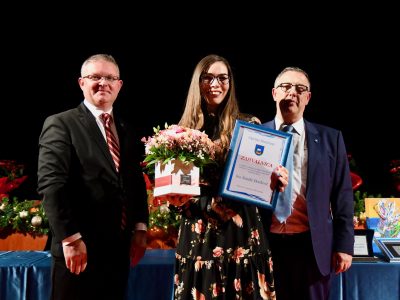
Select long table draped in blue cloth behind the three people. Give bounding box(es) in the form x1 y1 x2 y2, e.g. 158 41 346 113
0 250 400 300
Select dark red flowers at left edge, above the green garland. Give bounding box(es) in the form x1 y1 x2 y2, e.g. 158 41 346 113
0 160 28 203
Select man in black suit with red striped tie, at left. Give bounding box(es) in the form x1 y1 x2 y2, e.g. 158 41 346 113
38 54 148 300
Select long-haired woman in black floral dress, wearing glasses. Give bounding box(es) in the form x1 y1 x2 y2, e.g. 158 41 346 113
168 55 288 300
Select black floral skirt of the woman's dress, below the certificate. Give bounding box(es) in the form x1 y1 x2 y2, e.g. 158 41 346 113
174 188 275 300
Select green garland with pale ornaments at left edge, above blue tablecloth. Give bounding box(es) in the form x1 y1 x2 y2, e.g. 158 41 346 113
0 197 49 236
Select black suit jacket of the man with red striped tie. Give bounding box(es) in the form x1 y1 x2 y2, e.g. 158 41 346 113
38 103 148 256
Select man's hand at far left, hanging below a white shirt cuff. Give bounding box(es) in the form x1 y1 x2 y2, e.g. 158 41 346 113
63 239 87 275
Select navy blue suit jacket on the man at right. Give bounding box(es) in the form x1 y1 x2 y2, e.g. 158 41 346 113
263 120 354 275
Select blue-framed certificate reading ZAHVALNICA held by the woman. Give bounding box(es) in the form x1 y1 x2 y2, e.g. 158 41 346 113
220 120 292 210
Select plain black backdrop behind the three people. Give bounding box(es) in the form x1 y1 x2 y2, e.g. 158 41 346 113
0 8 400 197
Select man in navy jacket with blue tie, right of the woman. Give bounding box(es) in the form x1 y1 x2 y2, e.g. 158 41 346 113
263 67 354 300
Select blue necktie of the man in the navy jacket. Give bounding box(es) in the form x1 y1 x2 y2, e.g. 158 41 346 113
274 125 294 223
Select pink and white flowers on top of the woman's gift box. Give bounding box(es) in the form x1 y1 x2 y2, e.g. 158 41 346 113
142 124 217 169
